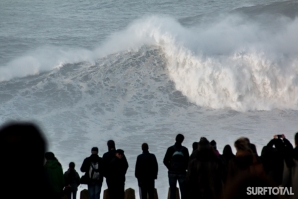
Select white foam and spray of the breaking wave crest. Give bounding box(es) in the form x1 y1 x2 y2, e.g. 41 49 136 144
0 15 298 111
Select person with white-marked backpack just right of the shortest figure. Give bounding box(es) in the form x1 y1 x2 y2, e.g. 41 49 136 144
81 147 103 199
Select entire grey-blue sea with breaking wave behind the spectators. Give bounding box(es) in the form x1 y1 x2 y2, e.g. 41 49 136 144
0 0 298 198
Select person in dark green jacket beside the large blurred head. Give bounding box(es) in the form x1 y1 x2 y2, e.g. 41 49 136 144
44 152 64 199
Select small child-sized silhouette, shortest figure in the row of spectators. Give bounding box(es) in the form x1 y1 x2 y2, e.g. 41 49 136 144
64 162 80 199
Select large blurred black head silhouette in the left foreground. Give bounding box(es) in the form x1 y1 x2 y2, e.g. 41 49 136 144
0 122 48 199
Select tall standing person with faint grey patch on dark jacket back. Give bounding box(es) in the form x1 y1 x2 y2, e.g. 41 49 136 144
163 134 189 199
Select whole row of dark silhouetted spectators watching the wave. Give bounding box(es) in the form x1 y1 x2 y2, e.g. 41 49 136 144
0 122 298 199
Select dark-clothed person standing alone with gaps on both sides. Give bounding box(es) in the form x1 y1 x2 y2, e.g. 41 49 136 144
135 143 158 199
